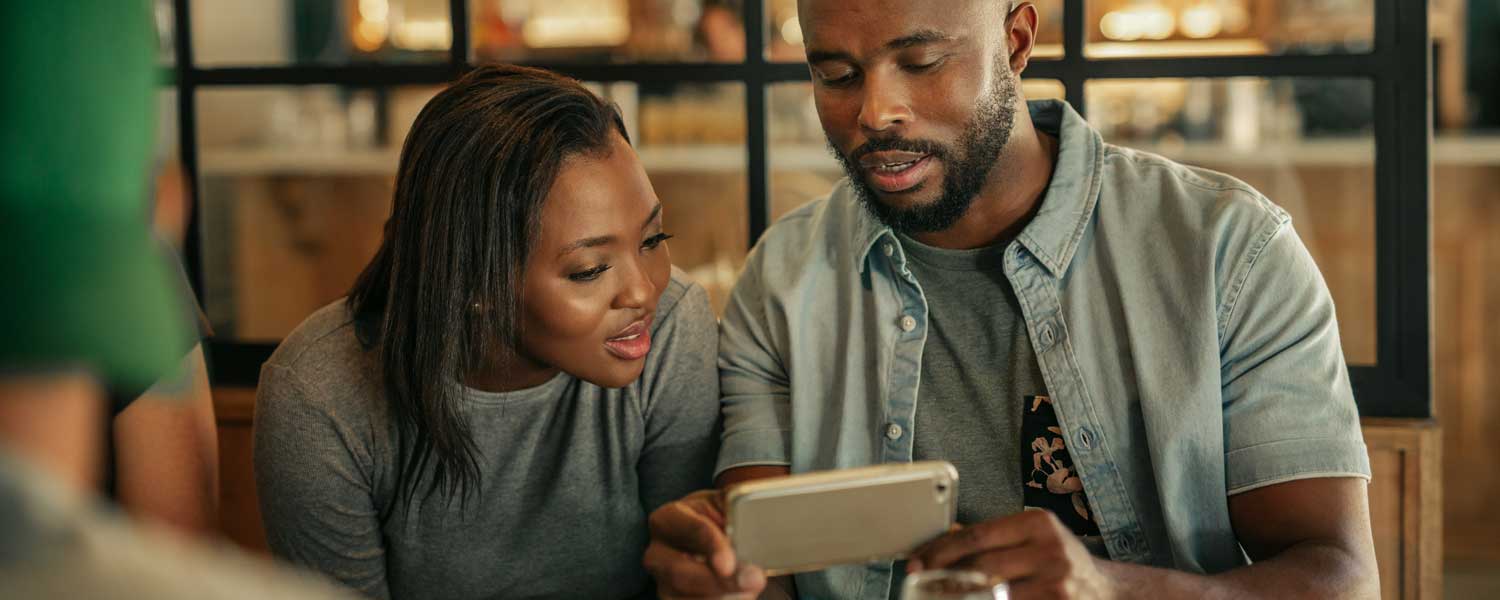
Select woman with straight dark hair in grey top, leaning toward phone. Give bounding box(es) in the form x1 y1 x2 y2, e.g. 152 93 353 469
255 68 719 599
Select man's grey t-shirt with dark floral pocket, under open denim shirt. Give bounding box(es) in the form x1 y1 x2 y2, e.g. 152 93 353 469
902 236 1047 525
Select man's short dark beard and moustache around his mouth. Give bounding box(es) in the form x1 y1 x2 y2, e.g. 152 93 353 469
828 61 1016 234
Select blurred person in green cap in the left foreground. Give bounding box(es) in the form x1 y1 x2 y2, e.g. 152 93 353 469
0 0 348 599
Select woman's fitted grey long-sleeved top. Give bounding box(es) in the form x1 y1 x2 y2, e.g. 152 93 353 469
255 270 720 599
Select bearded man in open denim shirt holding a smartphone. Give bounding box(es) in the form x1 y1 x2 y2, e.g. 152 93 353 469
645 0 1379 599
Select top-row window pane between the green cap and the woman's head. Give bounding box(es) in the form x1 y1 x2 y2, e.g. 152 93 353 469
191 0 453 68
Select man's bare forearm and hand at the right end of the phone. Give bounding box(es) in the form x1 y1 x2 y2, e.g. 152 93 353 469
908 477 1380 600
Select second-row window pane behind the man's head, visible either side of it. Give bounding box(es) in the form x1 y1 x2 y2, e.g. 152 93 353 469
767 80 1064 222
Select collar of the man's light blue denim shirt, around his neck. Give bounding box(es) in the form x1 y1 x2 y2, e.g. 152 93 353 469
854 101 1104 278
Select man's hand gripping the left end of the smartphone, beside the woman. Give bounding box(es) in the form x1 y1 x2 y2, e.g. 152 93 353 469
642 491 765 599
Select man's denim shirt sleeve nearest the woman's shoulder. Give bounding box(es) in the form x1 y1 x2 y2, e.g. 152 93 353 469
714 252 792 479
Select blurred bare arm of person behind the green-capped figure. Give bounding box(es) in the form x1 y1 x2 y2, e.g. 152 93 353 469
113 345 219 534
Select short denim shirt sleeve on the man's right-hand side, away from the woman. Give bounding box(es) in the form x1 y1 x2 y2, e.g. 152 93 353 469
1220 213 1370 495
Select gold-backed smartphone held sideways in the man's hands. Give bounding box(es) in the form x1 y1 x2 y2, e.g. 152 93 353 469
725 461 959 576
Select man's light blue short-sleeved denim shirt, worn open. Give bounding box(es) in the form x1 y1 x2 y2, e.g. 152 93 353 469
719 101 1370 600
